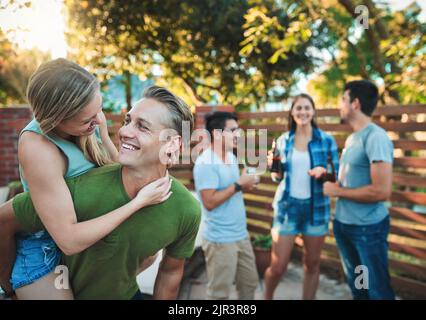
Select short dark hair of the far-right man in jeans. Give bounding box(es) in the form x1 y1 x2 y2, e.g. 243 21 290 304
345 80 379 116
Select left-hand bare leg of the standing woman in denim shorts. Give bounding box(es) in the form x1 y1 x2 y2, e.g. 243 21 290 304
264 233 296 300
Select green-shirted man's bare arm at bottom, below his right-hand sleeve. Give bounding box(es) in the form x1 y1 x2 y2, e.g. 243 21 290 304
154 254 185 300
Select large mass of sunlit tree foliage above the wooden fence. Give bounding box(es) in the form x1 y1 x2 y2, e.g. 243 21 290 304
61 0 426 110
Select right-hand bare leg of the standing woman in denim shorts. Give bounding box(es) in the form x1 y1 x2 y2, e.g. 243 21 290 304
302 236 325 300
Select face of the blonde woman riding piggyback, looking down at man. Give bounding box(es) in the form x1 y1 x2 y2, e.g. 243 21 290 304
56 91 102 137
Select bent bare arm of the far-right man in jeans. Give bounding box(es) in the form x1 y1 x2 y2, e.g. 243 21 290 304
324 162 392 203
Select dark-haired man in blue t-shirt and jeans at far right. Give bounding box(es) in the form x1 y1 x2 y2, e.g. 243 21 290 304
324 80 395 299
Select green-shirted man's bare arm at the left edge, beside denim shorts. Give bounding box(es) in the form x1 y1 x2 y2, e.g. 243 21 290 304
0 200 21 294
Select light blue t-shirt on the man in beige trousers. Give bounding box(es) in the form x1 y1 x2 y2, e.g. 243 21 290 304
194 148 248 243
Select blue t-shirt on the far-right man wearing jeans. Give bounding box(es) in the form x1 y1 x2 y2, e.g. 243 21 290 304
335 123 393 225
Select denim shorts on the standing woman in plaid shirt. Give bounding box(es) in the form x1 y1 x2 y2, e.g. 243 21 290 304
272 197 328 237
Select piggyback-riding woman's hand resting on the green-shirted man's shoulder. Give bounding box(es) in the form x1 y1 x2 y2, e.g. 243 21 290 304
134 172 172 208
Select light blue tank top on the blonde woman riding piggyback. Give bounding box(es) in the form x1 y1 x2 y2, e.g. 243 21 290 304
19 119 95 191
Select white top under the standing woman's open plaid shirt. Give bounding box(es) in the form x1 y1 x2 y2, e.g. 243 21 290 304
290 148 311 199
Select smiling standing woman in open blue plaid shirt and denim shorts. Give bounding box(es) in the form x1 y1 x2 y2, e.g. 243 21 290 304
265 94 338 299
